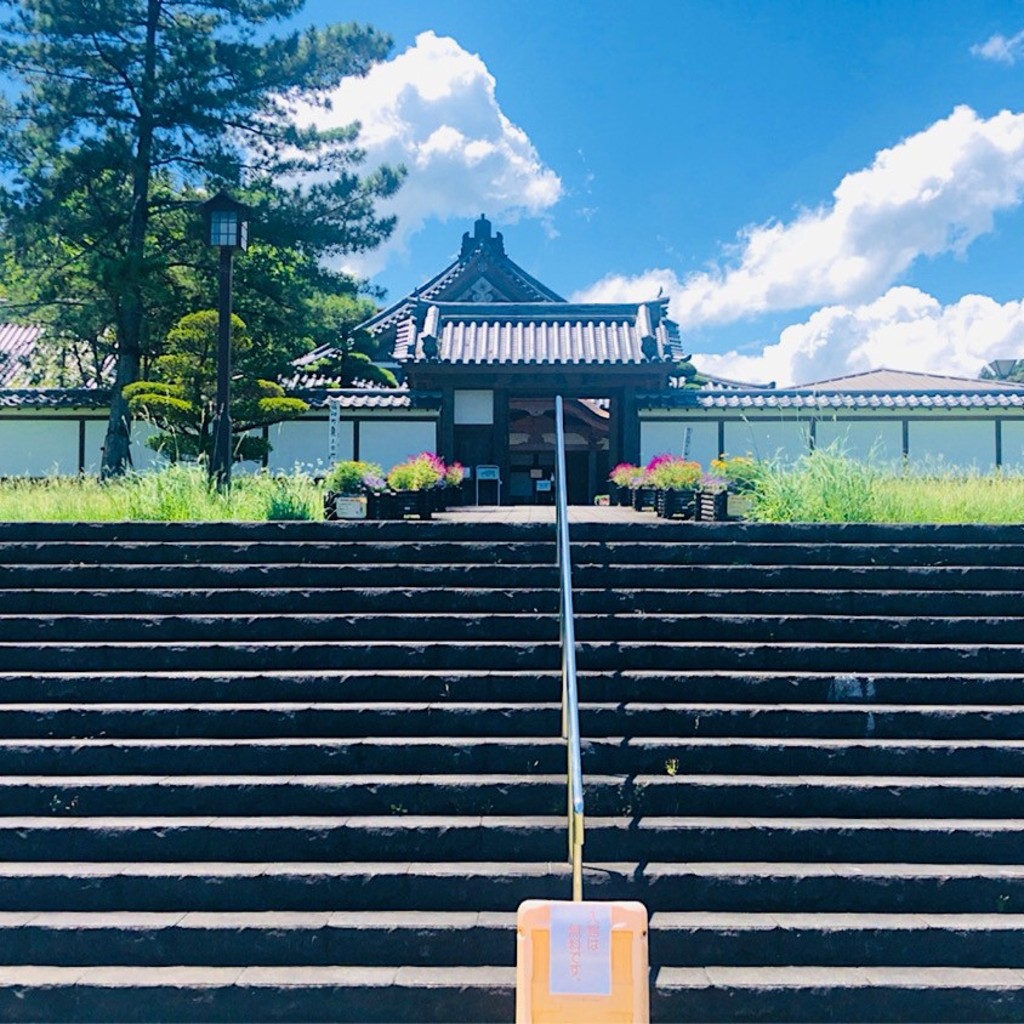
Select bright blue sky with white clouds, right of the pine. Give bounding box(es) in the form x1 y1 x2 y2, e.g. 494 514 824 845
290 0 1024 383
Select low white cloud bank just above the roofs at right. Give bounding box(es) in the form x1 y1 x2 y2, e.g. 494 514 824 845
693 287 1024 386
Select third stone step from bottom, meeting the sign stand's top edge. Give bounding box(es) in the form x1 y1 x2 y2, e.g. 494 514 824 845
0 860 1024 914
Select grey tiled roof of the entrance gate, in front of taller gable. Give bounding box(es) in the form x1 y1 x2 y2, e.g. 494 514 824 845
394 299 682 365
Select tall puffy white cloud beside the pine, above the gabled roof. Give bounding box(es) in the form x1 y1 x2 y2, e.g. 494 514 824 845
288 32 562 274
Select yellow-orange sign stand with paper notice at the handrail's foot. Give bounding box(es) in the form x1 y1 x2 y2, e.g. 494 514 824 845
515 899 650 1024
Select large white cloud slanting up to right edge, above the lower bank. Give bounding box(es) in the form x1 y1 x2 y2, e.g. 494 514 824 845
573 106 1024 327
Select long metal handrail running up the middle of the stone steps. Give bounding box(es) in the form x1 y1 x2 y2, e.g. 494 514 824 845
555 395 584 900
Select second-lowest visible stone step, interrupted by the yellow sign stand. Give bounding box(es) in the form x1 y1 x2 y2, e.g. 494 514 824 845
0 910 1024 968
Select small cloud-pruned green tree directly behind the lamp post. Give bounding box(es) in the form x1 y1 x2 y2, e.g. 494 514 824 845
124 309 309 462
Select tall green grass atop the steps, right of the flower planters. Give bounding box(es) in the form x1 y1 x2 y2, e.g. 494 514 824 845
751 449 1024 523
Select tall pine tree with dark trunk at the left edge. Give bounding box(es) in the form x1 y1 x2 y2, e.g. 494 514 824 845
0 0 401 475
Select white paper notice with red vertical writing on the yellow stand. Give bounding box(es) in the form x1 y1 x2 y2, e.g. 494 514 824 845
549 903 611 995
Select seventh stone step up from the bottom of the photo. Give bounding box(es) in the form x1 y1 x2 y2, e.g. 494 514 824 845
8 701 1024 739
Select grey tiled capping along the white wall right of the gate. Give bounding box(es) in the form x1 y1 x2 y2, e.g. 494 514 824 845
637 388 1024 411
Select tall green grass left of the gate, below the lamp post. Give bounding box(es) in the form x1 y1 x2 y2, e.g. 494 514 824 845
0 465 323 522
